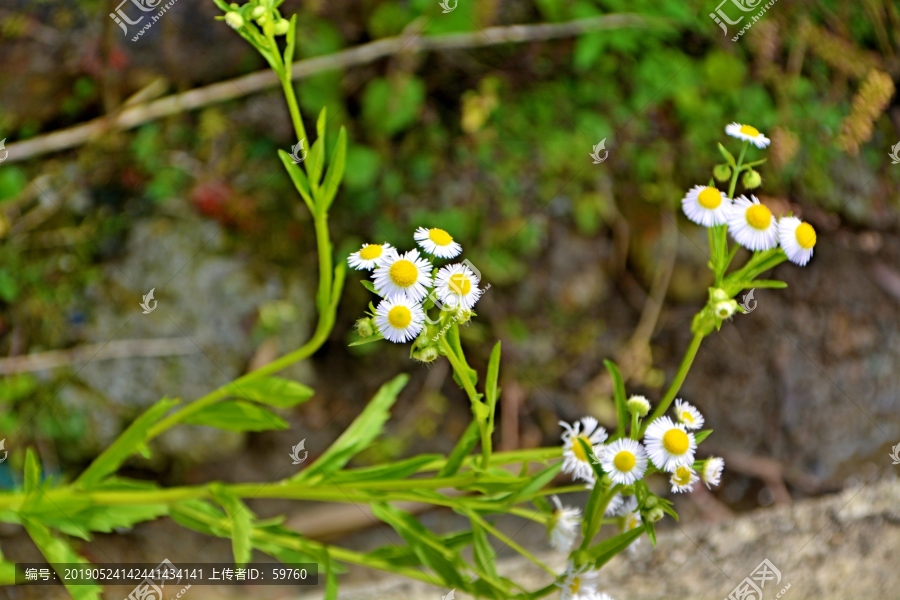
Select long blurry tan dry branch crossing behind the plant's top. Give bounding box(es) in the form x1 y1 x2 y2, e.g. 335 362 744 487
0 14 648 162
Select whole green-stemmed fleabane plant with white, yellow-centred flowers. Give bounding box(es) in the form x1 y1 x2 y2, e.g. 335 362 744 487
0 0 815 600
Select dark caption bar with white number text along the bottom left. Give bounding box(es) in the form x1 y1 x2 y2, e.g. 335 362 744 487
16 559 319 584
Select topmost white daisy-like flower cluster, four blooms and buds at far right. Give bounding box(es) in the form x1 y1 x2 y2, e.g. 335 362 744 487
681 123 816 266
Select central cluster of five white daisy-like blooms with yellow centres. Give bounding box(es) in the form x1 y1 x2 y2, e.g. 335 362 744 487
347 227 483 360
